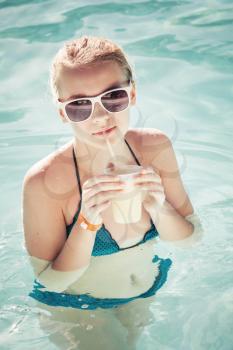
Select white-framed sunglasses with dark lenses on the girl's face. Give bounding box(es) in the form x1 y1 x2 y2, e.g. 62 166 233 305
57 82 131 123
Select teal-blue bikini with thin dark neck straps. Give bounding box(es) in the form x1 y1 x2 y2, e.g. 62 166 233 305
29 140 172 310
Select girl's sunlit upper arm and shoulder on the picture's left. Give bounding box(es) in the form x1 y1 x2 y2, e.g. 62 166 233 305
22 142 73 260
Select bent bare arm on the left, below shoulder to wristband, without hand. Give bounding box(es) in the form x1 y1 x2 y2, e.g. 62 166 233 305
23 175 95 292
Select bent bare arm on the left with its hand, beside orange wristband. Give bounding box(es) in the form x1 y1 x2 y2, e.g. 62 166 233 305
23 165 122 292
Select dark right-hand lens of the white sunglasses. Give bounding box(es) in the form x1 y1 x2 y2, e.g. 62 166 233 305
101 90 129 112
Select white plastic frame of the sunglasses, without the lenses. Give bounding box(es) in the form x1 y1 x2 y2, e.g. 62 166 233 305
56 81 132 124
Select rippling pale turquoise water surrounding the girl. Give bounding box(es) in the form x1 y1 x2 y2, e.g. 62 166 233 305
0 0 233 350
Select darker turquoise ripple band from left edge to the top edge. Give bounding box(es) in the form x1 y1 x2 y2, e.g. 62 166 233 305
0 1 182 42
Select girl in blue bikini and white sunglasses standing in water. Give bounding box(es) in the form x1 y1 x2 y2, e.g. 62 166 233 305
23 37 197 340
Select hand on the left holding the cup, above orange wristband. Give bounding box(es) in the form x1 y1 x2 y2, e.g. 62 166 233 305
80 175 125 225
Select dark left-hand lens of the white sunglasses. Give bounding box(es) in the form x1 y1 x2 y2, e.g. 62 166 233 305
65 100 92 122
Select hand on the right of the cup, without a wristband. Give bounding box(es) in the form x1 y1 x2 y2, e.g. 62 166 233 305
134 167 166 216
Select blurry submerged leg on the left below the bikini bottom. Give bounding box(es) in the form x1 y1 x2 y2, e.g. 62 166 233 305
36 305 128 350
